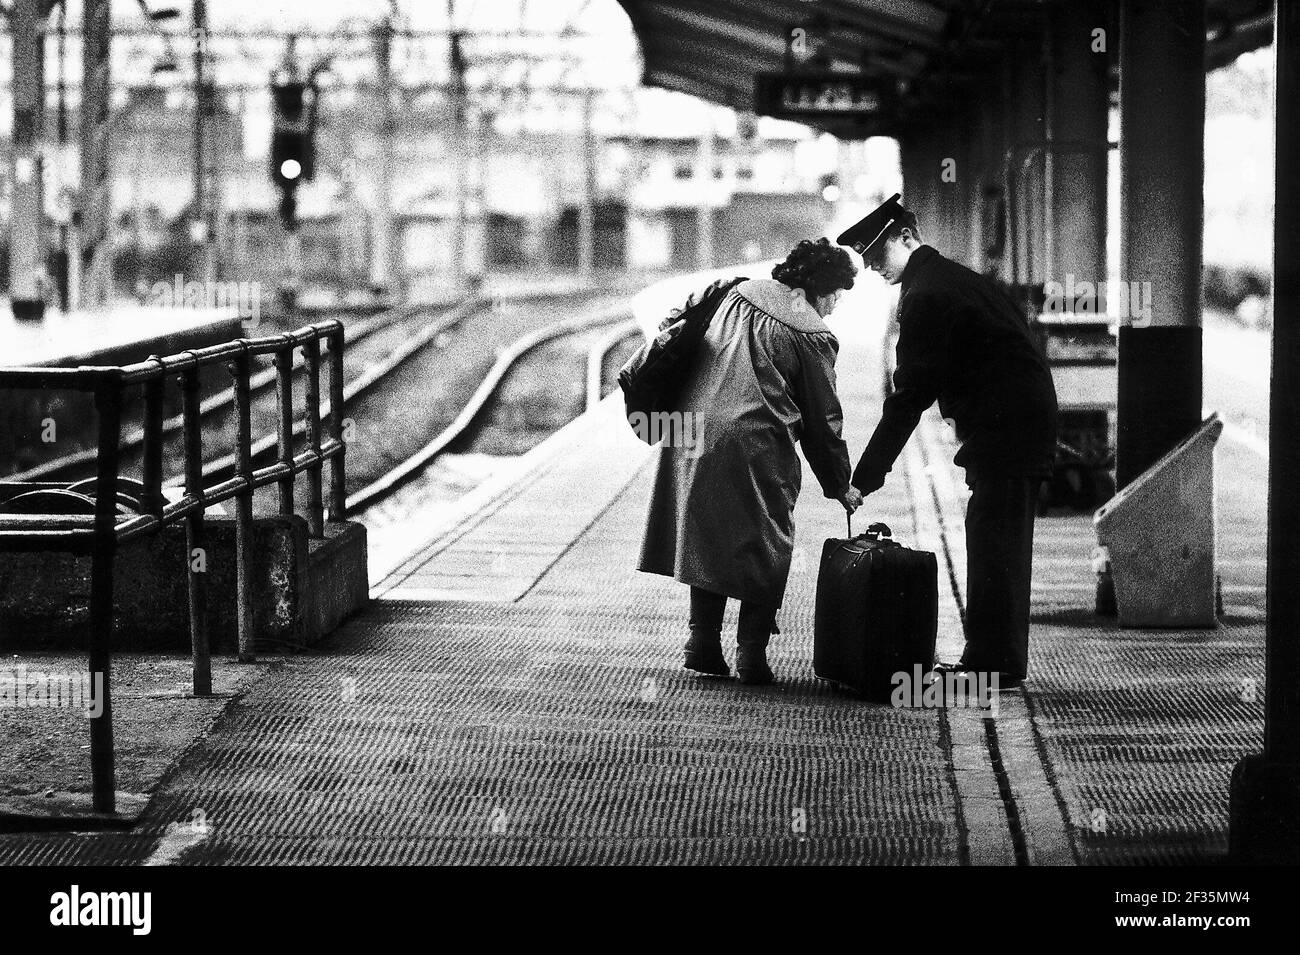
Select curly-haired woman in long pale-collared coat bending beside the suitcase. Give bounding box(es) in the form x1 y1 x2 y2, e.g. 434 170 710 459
638 239 862 683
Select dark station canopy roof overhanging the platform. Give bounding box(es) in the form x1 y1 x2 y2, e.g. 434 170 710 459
619 0 1273 138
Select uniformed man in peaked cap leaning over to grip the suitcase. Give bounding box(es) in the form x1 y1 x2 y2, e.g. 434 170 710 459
837 194 1057 687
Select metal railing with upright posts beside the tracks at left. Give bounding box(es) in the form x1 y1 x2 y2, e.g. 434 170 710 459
0 318 346 813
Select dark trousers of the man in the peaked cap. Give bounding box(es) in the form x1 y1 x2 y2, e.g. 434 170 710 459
962 472 1043 677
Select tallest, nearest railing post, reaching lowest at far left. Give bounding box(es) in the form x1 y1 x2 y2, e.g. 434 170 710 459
90 376 122 812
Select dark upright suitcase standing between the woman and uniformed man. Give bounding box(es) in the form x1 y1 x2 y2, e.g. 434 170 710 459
813 524 939 703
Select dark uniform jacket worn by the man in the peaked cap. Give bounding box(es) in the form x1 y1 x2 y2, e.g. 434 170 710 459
853 246 1057 494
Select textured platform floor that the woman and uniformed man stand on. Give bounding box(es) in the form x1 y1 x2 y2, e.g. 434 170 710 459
0 293 1264 865
